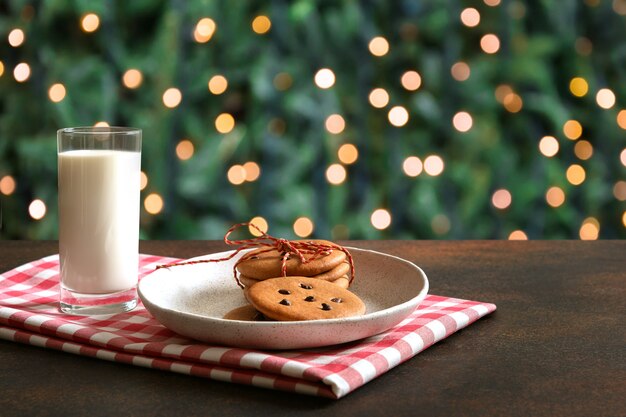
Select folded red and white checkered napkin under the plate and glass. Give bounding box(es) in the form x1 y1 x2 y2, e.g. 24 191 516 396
0 255 496 398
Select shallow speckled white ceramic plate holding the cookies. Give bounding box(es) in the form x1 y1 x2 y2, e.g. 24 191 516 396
139 248 428 349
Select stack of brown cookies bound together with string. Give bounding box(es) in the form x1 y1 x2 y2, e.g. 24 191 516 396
237 240 350 288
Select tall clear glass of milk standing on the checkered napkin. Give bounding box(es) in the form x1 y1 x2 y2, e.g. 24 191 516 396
57 127 141 315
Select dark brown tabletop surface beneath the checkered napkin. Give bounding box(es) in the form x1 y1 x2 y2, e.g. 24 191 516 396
0 241 626 417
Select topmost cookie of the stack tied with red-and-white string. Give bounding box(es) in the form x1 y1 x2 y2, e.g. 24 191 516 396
237 240 346 279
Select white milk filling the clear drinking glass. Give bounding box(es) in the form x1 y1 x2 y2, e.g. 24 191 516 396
59 150 141 294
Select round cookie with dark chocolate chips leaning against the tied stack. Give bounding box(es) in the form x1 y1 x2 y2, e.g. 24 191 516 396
244 276 365 321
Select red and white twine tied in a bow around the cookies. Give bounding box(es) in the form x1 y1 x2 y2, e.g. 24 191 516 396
156 223 354 288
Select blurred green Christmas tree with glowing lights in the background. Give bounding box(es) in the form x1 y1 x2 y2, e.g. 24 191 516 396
0 0 626 239
